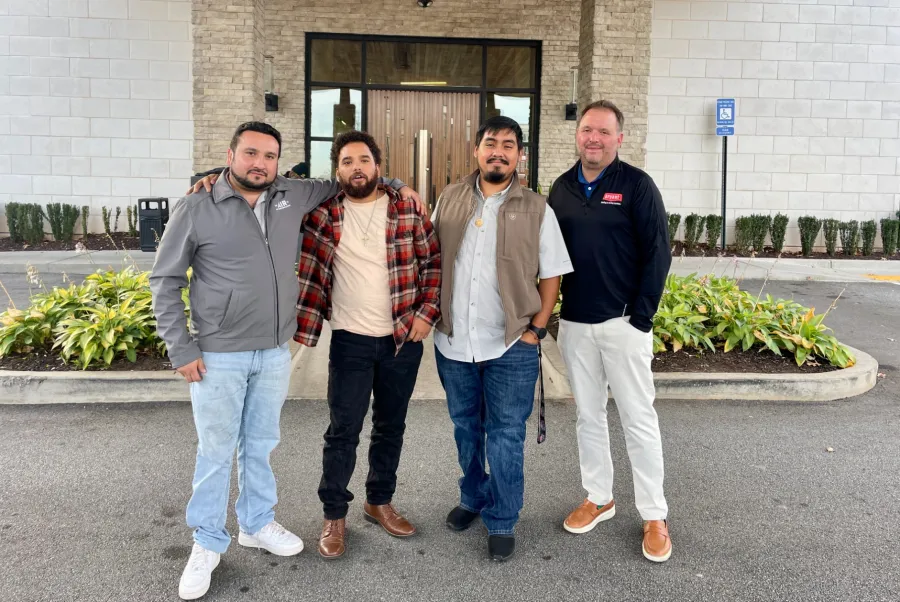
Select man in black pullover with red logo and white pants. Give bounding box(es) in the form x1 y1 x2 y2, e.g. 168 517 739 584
548 100 672 562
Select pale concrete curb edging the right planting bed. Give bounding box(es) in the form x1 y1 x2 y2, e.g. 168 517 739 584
544 336 878 401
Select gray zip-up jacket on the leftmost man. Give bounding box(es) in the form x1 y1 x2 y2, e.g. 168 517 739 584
150 170 404 368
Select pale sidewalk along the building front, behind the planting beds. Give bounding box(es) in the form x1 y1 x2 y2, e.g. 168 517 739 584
0 251 900 284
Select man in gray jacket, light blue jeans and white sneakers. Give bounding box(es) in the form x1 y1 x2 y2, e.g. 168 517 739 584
150 122 417 600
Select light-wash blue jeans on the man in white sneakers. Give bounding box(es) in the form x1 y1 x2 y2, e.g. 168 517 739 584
187 343 291 554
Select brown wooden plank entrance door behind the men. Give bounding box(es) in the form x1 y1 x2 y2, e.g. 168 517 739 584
368 90 480 207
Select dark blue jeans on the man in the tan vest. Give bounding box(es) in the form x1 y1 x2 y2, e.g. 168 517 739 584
435 341 538 535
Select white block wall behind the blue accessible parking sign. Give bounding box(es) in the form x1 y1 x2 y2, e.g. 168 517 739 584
647 0 900 245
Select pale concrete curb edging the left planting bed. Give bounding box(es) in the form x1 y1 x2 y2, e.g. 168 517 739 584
0 341 305 405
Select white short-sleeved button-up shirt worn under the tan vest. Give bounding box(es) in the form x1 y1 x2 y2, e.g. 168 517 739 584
432 175 572 362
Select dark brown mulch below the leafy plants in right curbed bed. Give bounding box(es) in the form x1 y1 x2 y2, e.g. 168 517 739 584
547 315 840 374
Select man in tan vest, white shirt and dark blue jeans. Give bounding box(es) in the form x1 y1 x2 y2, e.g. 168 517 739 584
432 117 572 560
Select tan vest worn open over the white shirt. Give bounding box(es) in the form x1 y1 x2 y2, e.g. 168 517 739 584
434 172 547 345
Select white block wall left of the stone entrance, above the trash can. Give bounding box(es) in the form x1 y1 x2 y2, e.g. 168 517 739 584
0 0 192 235
